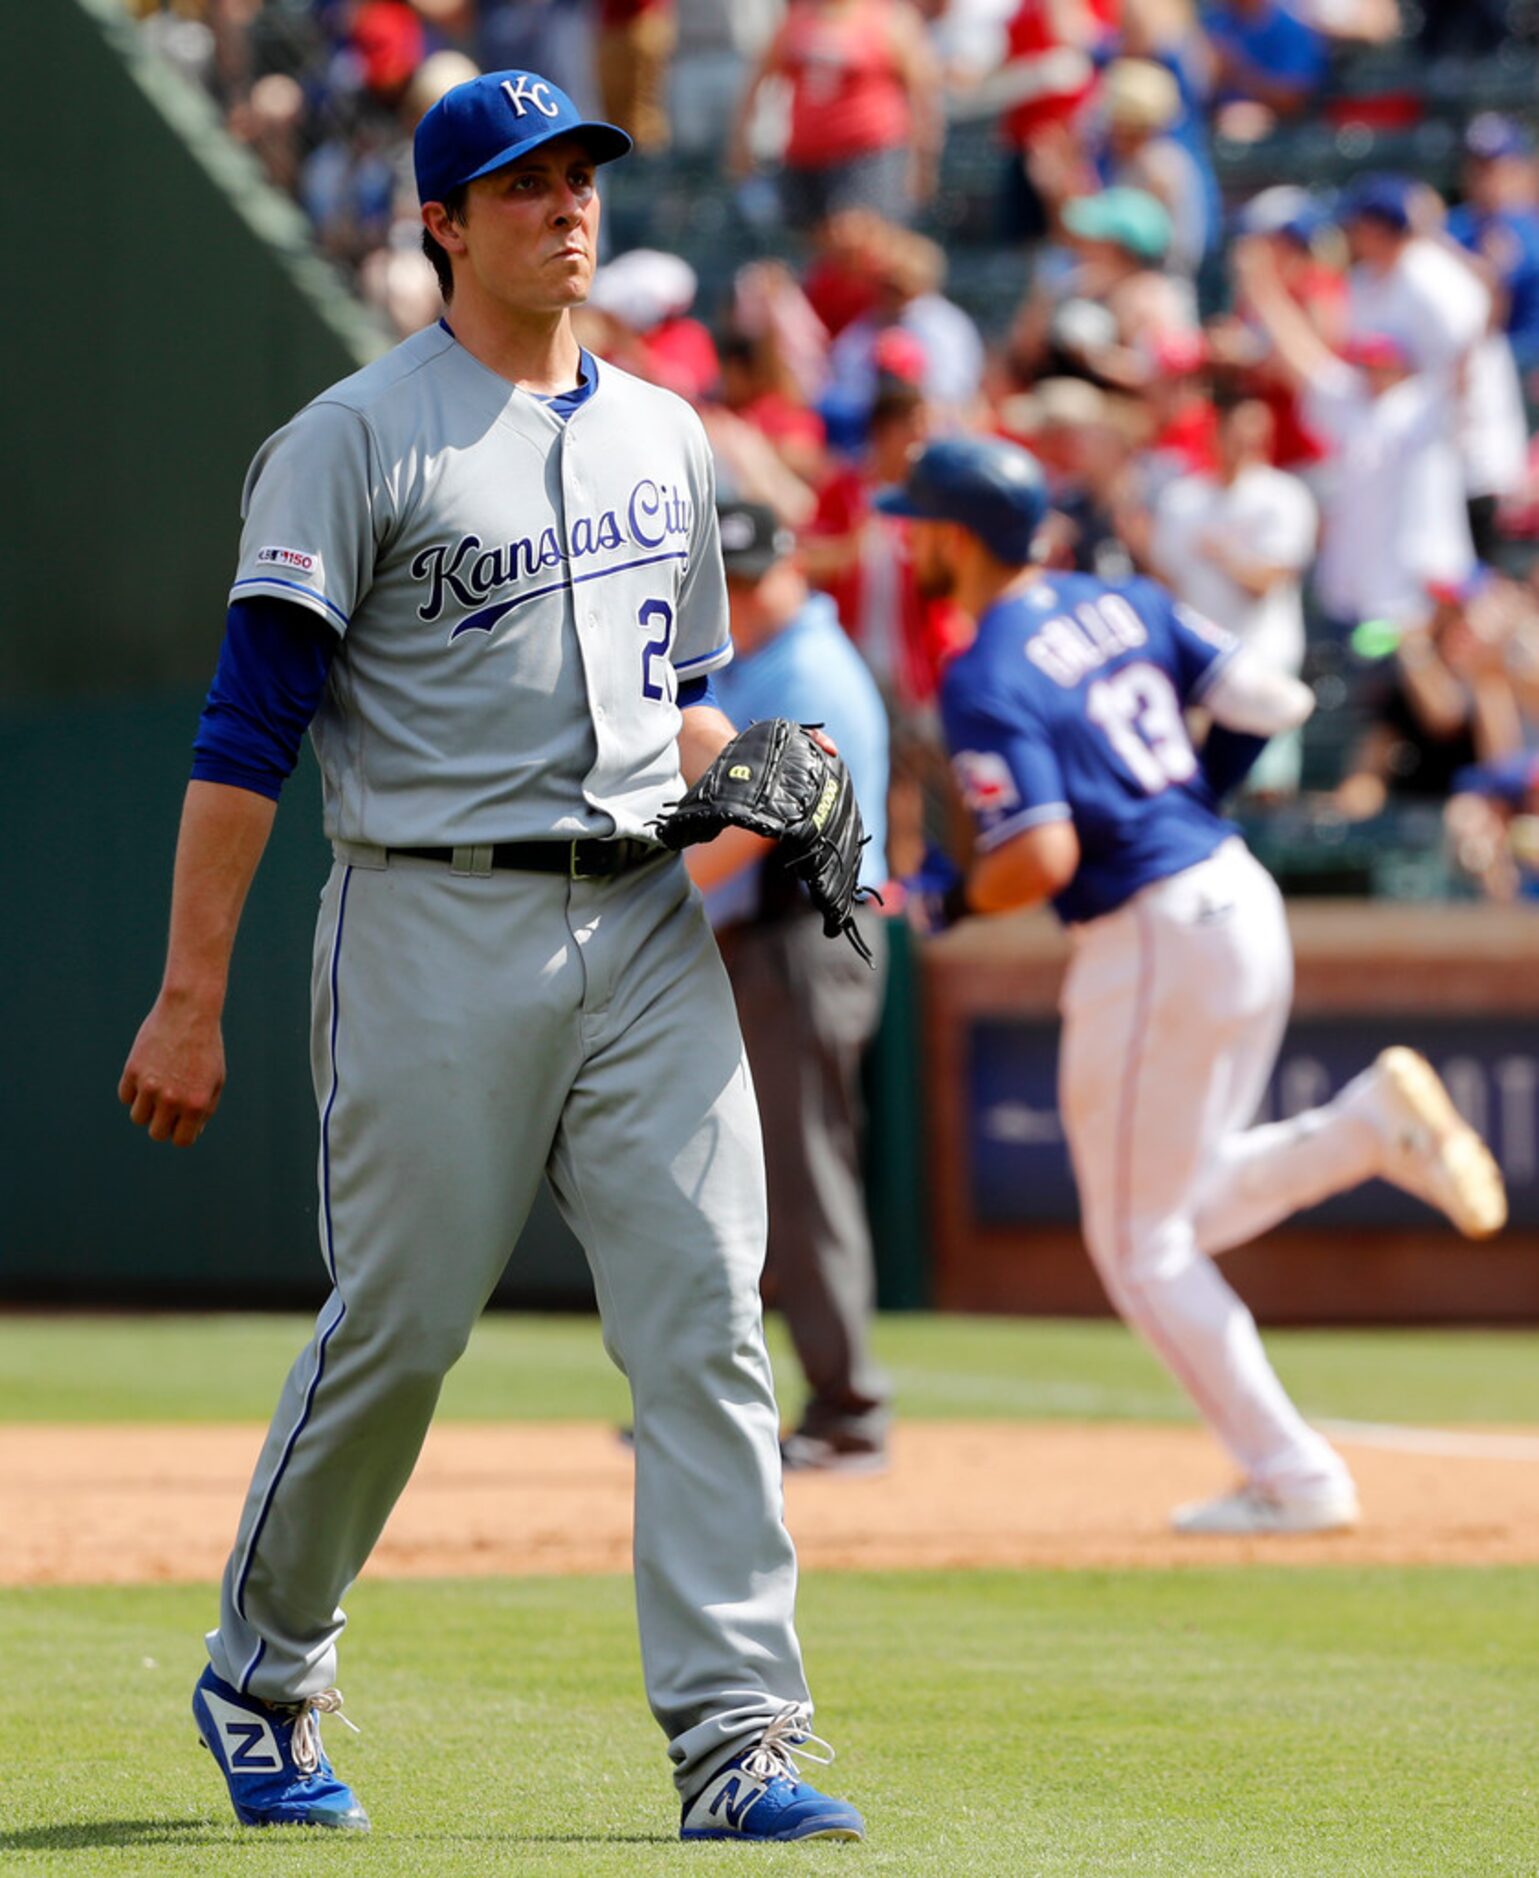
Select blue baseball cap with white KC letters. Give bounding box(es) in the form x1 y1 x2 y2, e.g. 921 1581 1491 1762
413 71 631 203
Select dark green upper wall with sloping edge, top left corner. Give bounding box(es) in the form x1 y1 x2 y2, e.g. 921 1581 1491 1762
0 0 387 700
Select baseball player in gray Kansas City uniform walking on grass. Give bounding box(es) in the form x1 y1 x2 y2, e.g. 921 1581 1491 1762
120 71 863 1839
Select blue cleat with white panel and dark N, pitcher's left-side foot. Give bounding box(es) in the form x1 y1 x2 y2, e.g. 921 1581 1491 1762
192 1670 368 1833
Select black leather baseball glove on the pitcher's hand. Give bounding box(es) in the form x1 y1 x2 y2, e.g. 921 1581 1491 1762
656 717 881 965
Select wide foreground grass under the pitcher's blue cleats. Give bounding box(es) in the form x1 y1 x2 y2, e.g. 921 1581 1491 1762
0 1570 1539 1878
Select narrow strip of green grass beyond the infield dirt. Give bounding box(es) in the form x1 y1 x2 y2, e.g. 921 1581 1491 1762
0 1315 1539 1424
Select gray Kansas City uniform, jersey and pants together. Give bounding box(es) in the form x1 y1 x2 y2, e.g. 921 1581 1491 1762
209 329 808 1793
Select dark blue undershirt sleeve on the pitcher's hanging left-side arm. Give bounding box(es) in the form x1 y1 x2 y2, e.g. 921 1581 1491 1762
192 593 338 802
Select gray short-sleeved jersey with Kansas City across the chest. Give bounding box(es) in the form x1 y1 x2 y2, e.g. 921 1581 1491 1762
231 325 731 847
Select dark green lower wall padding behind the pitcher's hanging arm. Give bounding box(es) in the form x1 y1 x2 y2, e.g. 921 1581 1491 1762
0 689 592 1305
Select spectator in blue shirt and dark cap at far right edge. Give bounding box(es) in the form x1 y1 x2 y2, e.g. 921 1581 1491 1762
1449 111 1539 372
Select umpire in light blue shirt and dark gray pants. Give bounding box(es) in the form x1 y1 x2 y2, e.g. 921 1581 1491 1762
690 503 889 1472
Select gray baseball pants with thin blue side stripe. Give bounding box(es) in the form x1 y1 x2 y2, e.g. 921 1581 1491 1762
209 847 806 1792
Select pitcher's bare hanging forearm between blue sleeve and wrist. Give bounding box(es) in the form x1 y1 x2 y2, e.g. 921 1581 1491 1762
162 781 278 1010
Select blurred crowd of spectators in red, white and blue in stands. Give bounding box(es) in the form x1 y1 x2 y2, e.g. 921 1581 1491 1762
126 0 1539 900
